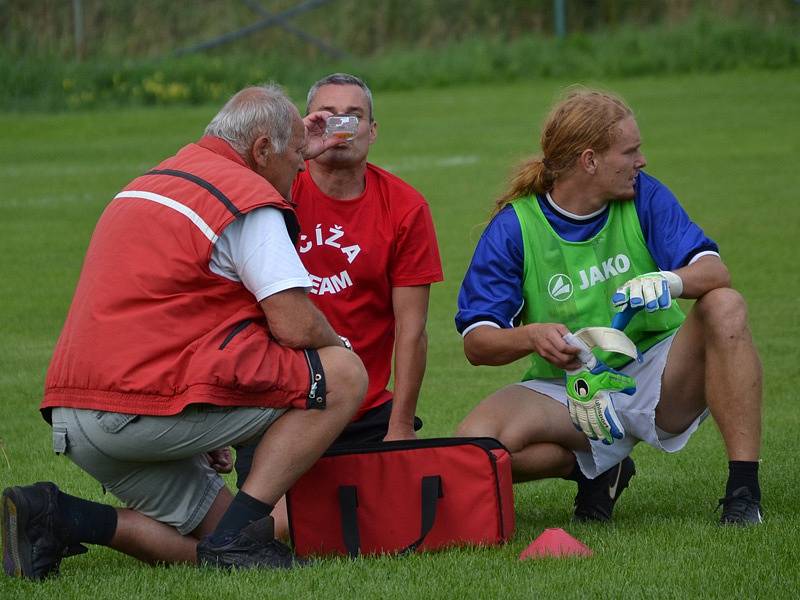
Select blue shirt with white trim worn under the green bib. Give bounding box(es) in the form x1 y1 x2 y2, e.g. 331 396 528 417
456 172 719 335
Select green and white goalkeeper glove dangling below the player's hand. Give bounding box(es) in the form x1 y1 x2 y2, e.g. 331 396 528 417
567 361 636 445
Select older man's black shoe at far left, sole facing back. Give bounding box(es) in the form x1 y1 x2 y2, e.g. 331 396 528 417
2 482 86 579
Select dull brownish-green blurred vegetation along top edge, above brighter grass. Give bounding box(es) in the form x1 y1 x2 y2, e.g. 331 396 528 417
0 0 800 60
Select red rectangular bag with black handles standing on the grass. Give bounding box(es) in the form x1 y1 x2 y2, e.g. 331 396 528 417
286 438 514 556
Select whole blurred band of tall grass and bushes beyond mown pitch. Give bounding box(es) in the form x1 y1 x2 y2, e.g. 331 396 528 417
0 0 800 110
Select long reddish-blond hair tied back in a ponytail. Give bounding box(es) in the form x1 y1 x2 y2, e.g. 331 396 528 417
492 88 633 216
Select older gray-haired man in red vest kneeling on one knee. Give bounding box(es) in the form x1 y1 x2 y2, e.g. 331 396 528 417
2 86 367 579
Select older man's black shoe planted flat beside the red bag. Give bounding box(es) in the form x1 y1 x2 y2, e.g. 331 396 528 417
197 517 305 569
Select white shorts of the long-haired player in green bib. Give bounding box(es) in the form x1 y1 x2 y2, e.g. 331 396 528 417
518 335 709 479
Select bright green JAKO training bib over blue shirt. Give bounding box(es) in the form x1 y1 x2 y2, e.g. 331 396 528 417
511 196 684 380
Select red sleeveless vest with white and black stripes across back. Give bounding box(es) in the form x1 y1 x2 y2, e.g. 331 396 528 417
40 137 306 418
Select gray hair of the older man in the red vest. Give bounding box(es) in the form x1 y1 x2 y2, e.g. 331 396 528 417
205 84 297 156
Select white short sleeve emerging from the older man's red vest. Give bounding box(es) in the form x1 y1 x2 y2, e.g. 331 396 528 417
209 206 311 302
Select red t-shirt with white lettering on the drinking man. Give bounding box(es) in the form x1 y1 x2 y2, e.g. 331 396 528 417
292 164 443 419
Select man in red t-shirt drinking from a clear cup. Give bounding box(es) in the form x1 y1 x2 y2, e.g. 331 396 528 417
236 73 443 536
